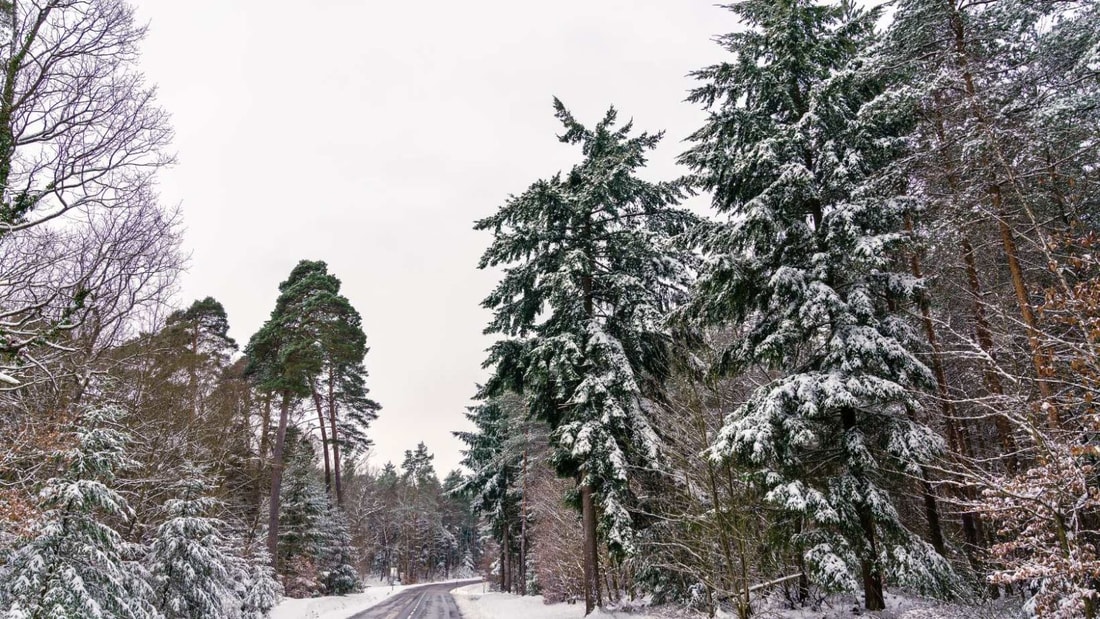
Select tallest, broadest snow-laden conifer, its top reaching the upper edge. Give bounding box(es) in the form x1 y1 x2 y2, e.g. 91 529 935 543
682 0 950 609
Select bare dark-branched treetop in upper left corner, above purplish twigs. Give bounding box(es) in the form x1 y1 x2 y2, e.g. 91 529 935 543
0 0 172 235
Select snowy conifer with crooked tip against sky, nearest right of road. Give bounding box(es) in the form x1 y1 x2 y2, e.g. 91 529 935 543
475 99 695 612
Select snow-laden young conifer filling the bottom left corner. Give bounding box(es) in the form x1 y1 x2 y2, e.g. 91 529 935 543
0 407 160 619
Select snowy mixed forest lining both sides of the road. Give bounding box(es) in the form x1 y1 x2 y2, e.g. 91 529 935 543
0 0 1100 619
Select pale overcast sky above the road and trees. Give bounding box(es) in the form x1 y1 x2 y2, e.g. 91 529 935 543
128 0 735 475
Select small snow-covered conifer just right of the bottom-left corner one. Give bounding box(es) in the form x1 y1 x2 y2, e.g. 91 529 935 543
145 467 243 619
